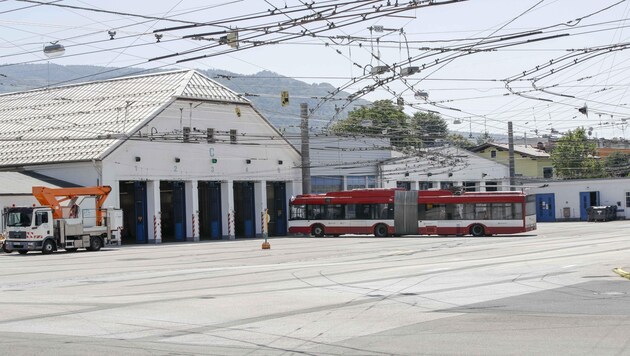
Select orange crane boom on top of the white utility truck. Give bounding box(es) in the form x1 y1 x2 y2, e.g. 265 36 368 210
33 185 112 226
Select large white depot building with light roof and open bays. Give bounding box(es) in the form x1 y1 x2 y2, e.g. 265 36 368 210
0 70 301 244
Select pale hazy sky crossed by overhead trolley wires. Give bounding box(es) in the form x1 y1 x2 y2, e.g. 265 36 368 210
0 0 630 139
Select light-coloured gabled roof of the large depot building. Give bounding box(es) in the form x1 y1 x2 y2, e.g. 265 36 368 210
0 70 249 167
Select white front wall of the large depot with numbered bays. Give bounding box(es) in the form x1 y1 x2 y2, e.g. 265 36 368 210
17 100 301 242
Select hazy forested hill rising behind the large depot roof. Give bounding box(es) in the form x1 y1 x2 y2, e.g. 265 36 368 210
0 63 370 132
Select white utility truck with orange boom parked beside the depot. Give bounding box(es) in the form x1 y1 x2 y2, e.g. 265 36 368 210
4 186 123 254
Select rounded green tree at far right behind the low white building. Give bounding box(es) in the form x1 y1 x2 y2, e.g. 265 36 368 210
551 127 605 179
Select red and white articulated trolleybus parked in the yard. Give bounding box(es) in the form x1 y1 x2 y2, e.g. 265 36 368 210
289 188 536 237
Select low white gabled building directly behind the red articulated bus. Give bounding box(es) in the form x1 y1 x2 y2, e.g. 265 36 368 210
379 147 510 191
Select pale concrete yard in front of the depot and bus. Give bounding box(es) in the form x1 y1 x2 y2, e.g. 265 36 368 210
0 221 630 355
